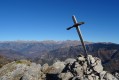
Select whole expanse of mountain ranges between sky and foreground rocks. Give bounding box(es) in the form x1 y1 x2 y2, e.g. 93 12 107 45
0 40 119 72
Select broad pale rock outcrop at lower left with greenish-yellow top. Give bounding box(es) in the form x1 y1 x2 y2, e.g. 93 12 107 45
0 60 41 80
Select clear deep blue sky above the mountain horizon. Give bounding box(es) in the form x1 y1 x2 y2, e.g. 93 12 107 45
0 0 119 43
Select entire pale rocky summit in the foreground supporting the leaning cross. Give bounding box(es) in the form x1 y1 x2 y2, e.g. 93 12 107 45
0 55 119 80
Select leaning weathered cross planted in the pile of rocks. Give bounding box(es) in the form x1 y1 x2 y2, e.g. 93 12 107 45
67 16 88 56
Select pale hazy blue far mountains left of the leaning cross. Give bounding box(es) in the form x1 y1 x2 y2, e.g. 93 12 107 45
0 40 90 58
